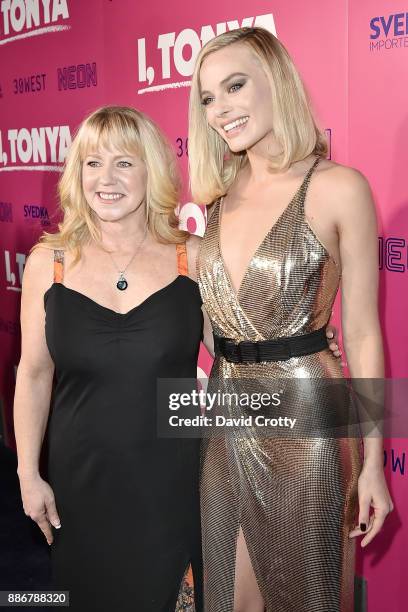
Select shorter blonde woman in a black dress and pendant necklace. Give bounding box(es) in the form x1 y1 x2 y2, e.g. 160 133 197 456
15 107 203 612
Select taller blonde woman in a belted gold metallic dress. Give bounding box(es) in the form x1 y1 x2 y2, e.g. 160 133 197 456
189 28 393 612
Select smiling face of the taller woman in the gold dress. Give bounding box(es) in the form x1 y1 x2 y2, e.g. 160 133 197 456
200 43 273 152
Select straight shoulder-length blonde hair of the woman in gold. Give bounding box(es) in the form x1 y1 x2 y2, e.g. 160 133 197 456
188 27 327 204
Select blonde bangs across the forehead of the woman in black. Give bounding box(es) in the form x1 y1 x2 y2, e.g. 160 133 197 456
79 112 144 161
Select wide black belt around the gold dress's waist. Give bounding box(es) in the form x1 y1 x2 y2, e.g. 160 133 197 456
213 326 327 363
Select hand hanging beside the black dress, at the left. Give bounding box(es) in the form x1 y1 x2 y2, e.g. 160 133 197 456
19 474 61 544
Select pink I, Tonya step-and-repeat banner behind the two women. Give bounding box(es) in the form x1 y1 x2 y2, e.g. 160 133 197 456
0 0 408 612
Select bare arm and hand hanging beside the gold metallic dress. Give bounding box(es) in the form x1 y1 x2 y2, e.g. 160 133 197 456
333 168 393 546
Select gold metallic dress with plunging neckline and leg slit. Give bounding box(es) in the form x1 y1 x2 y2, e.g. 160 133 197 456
198 159 361 612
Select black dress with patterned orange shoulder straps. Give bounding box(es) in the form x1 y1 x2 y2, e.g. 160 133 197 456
44 245 203 612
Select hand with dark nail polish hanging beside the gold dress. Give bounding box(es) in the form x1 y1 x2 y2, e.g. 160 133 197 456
349 465 394 548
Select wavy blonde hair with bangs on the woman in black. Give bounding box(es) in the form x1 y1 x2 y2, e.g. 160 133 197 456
33 106 188 263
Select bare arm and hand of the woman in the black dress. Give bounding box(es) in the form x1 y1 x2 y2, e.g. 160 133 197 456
14 248 59 543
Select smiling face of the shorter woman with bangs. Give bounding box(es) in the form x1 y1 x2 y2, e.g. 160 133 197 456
82 148 147 221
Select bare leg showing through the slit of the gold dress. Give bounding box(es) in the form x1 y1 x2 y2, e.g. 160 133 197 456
234 527 265 612
